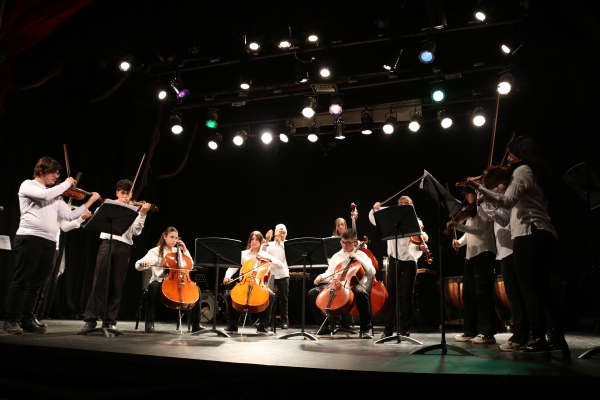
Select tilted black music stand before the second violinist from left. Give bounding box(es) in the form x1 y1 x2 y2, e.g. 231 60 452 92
77 199 138 337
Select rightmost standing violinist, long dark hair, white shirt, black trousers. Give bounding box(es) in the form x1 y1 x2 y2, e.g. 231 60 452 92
473 136 571 358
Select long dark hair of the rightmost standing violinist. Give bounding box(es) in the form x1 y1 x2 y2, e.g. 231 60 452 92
508 136 554 201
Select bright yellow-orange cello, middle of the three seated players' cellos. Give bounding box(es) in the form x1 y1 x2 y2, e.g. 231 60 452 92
231 256 271 313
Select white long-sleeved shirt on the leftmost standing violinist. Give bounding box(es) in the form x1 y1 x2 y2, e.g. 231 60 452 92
17 180 87 242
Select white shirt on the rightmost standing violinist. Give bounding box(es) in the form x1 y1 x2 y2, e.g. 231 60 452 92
478 165 557 239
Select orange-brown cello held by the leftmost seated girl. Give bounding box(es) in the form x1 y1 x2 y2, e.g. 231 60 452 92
160 242 200 310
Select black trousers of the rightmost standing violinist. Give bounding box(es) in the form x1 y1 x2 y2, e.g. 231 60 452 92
513 225 562 338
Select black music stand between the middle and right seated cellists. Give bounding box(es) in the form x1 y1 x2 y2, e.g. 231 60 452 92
279 238 329 340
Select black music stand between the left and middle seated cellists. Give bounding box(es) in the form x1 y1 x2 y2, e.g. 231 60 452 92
190 237 243 337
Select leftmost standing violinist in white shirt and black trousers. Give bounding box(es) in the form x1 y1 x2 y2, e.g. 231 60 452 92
4 157 100 334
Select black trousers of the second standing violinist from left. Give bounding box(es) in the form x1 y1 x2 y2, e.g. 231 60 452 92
83 240 131 324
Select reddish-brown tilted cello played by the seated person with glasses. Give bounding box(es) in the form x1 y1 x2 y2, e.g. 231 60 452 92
316 236 369 317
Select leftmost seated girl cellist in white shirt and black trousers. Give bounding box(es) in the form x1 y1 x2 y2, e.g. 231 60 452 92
135 226 204 333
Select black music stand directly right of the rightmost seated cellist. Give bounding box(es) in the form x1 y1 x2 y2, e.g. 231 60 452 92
373 205 423 345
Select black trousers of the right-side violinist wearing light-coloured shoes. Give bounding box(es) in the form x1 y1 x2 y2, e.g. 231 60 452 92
462 251 497 336
